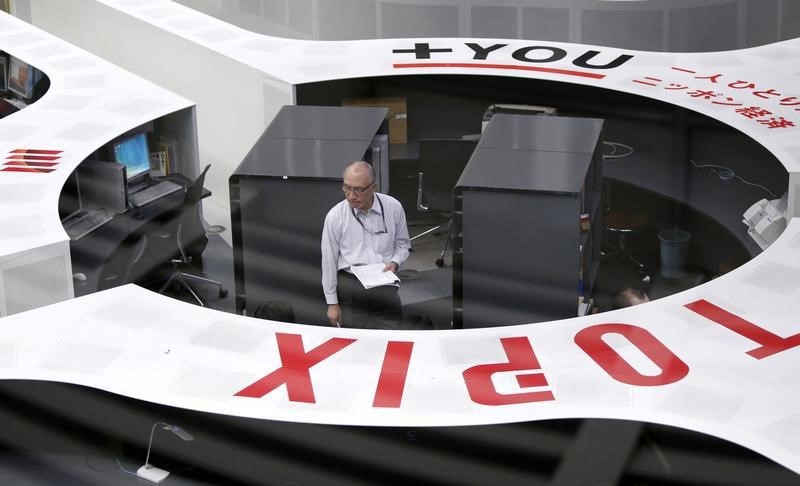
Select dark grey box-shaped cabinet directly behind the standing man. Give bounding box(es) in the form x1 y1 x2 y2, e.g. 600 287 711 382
229 106 386 325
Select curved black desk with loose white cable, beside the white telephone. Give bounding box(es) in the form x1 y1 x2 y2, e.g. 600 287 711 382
604 118 788 257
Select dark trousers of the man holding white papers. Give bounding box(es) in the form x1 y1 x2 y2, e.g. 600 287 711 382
336 271 403 329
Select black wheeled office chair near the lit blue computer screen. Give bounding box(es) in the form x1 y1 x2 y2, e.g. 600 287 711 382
158 165 228 307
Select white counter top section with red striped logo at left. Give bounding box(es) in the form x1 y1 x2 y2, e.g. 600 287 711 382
0 13 193 264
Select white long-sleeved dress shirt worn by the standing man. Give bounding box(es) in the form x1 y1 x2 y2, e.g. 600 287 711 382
322 193 411 304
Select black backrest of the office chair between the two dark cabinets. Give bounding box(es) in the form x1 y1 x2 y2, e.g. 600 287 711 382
419 139 478 212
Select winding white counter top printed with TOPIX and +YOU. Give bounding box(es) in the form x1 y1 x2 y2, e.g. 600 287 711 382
0 0 800 473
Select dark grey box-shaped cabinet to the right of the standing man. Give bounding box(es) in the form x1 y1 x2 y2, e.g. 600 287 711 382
453 114 603 328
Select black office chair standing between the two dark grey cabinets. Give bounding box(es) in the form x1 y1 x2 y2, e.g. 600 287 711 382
411 139 478 267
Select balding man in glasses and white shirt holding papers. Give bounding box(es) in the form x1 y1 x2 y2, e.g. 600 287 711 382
321 161 411 329
